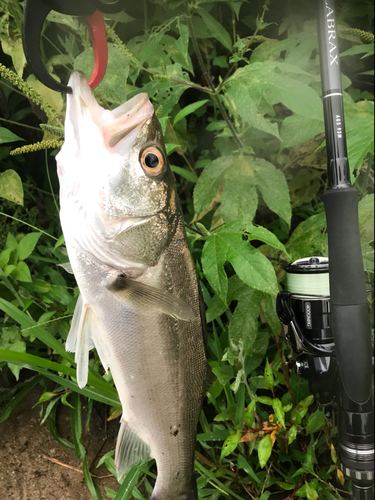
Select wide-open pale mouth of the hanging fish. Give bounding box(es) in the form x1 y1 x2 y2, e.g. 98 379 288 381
66 71 154 154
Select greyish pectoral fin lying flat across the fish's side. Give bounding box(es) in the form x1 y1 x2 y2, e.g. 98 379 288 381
105 275 196 321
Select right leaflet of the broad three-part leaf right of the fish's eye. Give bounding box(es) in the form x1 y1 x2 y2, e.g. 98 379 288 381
255 158 292 226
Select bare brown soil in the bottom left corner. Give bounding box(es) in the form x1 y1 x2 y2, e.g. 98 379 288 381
0 387 119 500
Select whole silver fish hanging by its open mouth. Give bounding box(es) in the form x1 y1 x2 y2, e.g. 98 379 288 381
56 71 207 500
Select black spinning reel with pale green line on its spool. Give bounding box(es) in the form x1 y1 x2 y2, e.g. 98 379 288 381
277 257 338 405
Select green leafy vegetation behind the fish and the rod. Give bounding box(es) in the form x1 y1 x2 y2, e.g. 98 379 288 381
0 0 374 500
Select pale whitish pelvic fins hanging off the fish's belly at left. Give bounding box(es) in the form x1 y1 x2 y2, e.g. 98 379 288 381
65 295 110 388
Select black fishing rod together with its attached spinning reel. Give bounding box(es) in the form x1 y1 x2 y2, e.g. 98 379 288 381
277 0 374 500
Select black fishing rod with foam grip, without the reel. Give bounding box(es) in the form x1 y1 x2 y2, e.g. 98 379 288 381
318 0 374 492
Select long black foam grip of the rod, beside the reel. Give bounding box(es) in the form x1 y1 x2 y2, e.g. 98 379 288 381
323 186 372 409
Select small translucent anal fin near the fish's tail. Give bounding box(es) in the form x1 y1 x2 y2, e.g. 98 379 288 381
115 420 150 480
